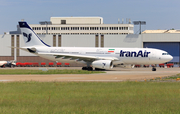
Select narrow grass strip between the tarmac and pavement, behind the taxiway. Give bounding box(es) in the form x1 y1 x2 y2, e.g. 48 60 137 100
0 69 105 75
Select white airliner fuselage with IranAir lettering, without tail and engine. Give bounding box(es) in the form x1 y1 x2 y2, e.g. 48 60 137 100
28 47 173 65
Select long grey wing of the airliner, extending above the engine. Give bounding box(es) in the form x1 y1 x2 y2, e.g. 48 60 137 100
38 53 119 61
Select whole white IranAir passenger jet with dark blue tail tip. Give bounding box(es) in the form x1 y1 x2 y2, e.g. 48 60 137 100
19 22 173 71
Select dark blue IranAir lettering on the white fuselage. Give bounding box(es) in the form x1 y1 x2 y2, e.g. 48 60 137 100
120 50 151 57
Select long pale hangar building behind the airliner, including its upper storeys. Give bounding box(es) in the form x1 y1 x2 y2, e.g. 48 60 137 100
0 17 180 66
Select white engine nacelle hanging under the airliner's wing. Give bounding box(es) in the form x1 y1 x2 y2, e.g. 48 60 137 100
92 60 113 69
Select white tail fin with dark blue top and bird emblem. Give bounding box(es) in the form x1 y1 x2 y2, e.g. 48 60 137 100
19 22 50 47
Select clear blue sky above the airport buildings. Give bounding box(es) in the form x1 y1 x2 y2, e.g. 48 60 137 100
0 0 180 34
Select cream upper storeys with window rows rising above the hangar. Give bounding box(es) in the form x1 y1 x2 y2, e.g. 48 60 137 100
30 17 134 35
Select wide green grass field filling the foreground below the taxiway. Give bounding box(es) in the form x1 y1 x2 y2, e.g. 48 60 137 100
0 81 180 114
